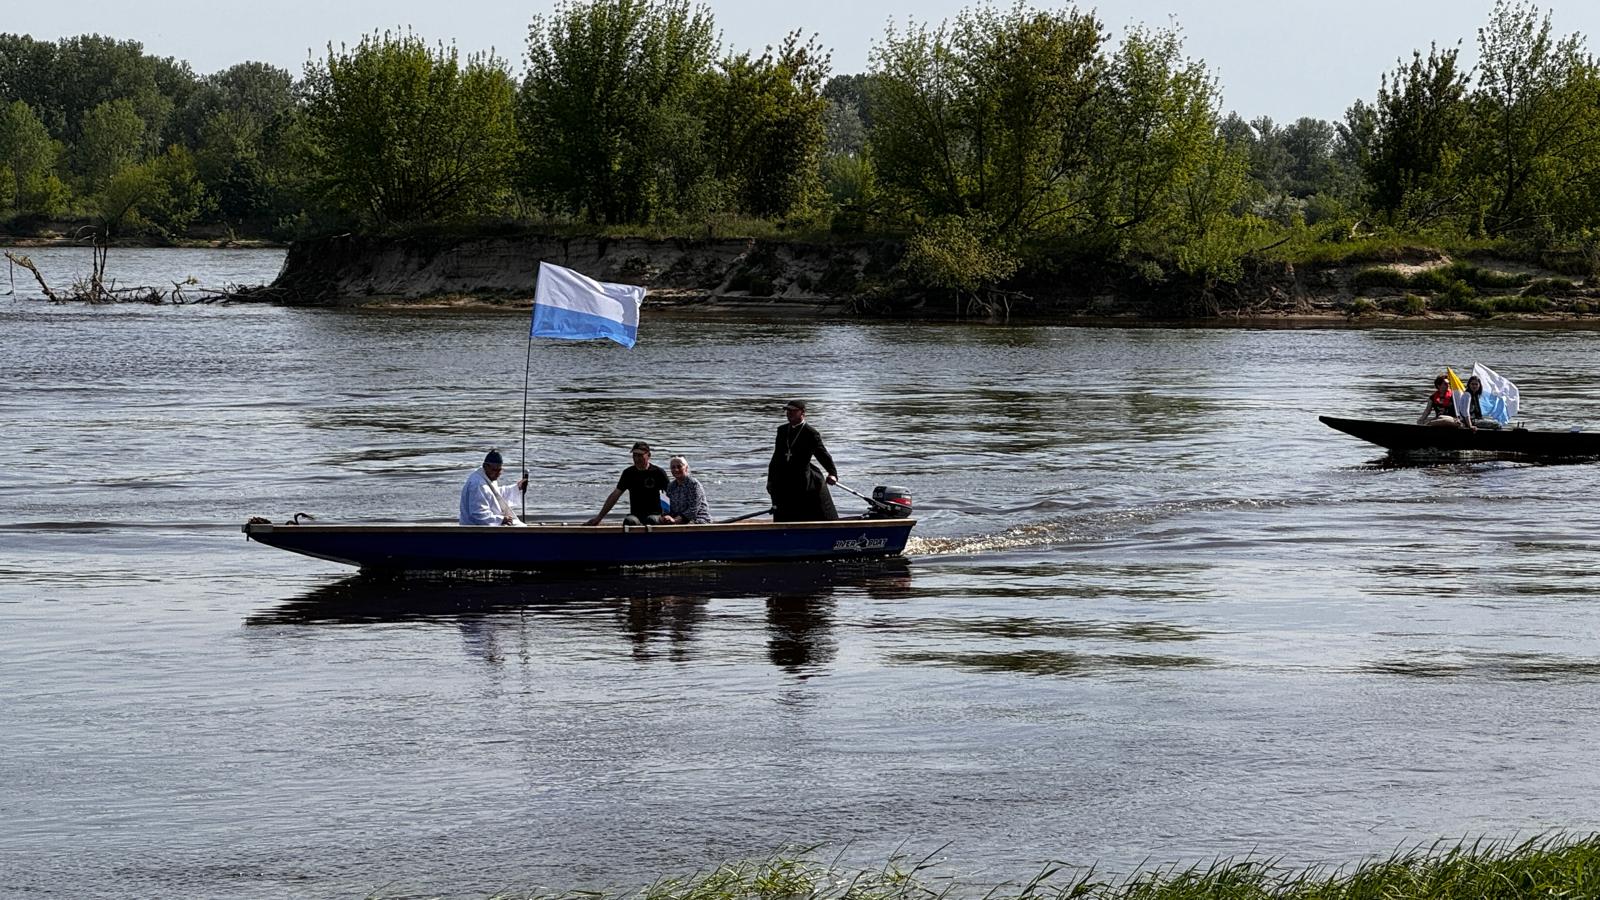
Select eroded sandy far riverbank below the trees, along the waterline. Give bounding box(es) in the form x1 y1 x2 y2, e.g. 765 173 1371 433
261 235 1600 322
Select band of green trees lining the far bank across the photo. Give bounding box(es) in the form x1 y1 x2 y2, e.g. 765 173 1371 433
0 0 1600 291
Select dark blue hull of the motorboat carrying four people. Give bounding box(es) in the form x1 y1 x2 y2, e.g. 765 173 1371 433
243 519 917 572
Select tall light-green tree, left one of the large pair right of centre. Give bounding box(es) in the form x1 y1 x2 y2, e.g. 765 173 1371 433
869 5 1104 235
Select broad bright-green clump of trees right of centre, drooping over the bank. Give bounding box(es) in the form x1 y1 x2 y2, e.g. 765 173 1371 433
867 3 1241 280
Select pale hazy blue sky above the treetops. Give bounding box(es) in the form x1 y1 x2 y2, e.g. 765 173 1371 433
9 0 1600 123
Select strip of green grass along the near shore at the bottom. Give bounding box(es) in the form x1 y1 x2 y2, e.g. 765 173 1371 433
373 834 1600 900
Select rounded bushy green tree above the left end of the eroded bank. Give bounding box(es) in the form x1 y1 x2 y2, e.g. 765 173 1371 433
306 32 517 227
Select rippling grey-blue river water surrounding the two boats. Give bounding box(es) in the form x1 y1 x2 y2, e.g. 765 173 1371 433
0 248 1600 897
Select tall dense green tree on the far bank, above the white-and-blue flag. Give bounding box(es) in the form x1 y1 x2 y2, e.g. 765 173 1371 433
517 0 715 224
